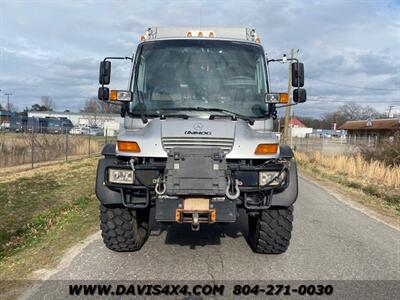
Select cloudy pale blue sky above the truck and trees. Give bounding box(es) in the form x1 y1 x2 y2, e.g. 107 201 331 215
0 0 400 117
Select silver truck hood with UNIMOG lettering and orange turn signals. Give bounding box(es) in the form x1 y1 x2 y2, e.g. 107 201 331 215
117 118 279 159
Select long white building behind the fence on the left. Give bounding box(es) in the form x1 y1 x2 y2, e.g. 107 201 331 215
28 111 124 130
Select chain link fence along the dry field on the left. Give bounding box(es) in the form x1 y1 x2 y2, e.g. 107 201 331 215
0 127 116 168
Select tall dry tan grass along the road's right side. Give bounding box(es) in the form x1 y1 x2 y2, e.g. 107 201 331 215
296 152 400 216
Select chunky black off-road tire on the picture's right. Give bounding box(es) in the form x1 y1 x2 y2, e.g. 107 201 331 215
249 205 293 254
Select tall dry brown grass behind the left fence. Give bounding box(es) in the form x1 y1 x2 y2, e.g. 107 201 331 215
0 132 105 167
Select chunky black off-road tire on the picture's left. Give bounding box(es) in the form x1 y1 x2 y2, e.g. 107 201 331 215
100 204 150 252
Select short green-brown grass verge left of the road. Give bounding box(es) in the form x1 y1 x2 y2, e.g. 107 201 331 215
0 158 98 290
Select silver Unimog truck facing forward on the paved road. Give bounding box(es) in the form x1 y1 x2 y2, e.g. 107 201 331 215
96 27 306 253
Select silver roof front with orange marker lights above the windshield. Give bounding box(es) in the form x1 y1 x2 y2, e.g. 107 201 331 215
140 27 260 43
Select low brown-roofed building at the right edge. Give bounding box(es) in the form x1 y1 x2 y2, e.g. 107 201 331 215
339 118 400 140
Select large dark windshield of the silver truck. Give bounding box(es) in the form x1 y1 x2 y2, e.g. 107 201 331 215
130 40 266 118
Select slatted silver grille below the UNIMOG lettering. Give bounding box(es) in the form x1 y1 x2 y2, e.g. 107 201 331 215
162 137 233 153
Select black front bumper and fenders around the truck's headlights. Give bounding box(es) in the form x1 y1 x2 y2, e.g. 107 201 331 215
96 157 298 216
